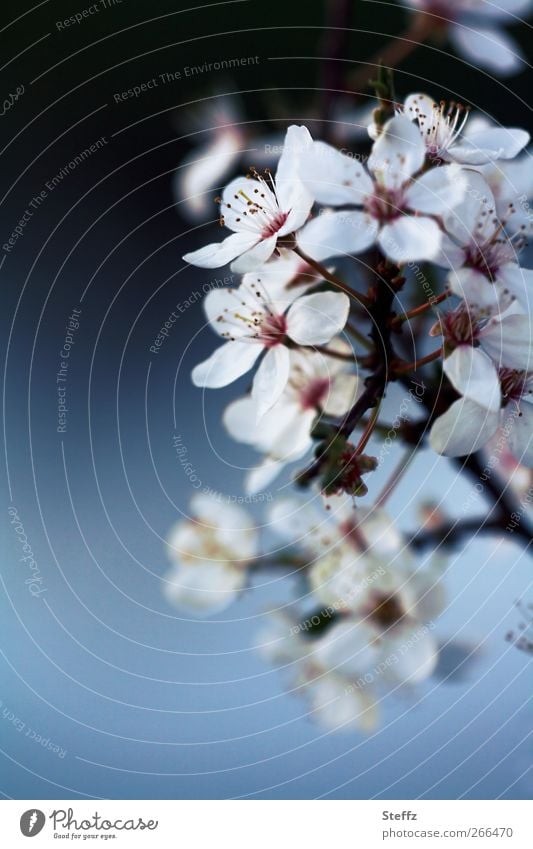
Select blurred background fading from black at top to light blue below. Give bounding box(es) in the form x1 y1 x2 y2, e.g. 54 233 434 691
0 0 533 799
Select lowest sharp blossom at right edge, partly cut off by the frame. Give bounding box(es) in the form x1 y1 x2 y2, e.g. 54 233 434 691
429 368 533 460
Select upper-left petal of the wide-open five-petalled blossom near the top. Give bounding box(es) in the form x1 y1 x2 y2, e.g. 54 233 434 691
300 142 373 206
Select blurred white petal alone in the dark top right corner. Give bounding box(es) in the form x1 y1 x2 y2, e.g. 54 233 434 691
450 26 525 76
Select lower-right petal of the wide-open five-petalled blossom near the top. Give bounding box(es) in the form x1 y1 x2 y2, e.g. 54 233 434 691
378 215 441 263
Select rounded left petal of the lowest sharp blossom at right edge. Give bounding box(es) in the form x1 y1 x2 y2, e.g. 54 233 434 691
429 398 500 457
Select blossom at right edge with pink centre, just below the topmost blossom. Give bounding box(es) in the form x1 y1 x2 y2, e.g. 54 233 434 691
438 171 533 311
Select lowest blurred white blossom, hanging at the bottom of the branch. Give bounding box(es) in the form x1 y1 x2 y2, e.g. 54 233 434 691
258 616 378 733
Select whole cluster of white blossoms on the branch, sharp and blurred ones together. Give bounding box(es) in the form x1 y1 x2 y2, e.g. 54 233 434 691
165 89 533 730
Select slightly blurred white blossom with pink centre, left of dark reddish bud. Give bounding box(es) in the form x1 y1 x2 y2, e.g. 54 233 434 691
224 339 358 492
